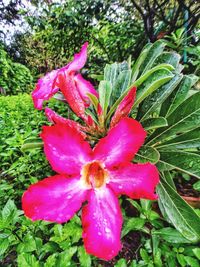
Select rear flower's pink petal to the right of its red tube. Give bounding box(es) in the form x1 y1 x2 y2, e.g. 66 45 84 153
74 74 99 107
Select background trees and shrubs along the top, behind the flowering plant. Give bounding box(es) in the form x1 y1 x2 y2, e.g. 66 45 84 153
0 0 200 94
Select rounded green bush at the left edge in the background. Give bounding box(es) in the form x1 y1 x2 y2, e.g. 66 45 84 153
0 45 33 94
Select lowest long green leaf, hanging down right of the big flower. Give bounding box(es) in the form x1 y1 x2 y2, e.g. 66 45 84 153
157 177 200 242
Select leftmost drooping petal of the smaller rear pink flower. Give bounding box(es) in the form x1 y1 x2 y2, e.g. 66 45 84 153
32 69 59 109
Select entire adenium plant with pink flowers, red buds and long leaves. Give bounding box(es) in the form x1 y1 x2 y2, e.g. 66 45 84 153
22 40 200 260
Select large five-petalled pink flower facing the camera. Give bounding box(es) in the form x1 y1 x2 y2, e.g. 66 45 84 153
22 118 159 260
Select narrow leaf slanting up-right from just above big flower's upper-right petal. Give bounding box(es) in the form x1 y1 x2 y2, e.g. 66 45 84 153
138 74 183 120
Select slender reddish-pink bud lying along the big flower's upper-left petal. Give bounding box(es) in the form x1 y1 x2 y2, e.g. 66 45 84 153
45 108 87 139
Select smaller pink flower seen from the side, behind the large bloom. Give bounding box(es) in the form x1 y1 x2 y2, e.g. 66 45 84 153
32 43 98 122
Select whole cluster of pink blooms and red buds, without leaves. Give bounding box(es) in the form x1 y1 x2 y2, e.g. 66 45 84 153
22 43 159 260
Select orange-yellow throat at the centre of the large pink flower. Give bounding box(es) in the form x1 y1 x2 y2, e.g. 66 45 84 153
81 161 108 188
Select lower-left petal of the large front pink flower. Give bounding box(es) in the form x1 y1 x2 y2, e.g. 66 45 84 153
22 175 87 223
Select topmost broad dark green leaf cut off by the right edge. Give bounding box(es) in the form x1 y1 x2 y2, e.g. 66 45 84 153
148 92 200 147
